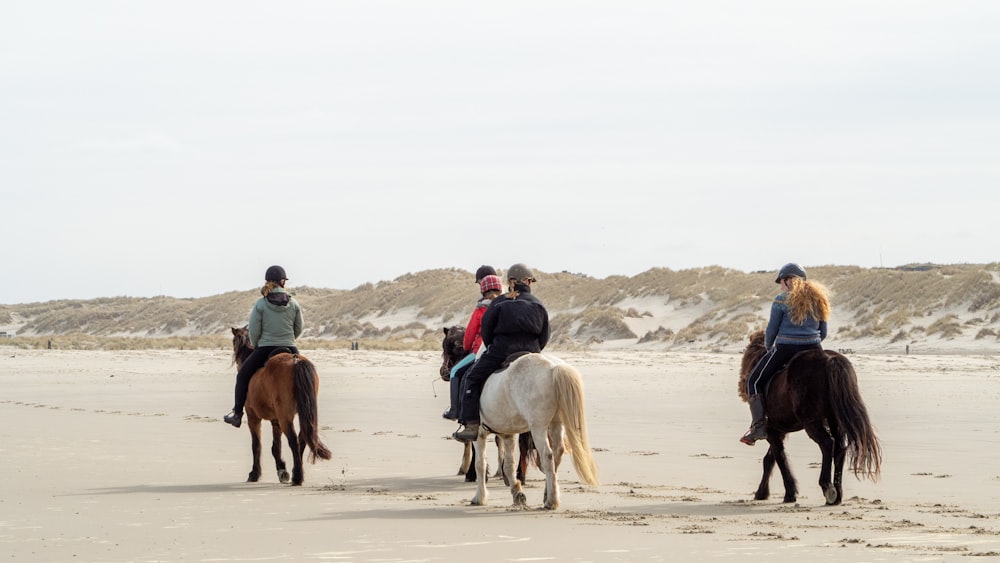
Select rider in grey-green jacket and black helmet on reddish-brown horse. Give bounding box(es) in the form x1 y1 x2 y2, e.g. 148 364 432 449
222 266 302 428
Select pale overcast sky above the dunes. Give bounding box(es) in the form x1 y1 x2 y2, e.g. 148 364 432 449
0 0 1000 304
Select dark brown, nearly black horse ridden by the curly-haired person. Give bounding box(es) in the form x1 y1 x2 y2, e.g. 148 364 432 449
739 330 882 505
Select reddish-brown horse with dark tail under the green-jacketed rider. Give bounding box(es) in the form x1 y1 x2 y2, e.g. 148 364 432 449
233 327 331 485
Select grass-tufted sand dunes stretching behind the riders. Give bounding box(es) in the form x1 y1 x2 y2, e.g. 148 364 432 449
0 263 1000 350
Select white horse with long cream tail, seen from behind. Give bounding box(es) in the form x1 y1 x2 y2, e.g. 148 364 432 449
472 354 600 509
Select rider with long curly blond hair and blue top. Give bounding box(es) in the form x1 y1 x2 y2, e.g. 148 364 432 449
740 263 830 446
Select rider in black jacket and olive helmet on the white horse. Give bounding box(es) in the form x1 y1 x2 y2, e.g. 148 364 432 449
452 263 549 442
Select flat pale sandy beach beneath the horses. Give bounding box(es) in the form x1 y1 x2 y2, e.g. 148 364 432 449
0 348 1000 562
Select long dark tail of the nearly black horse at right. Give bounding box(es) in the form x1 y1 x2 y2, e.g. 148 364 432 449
827 354 882 481
